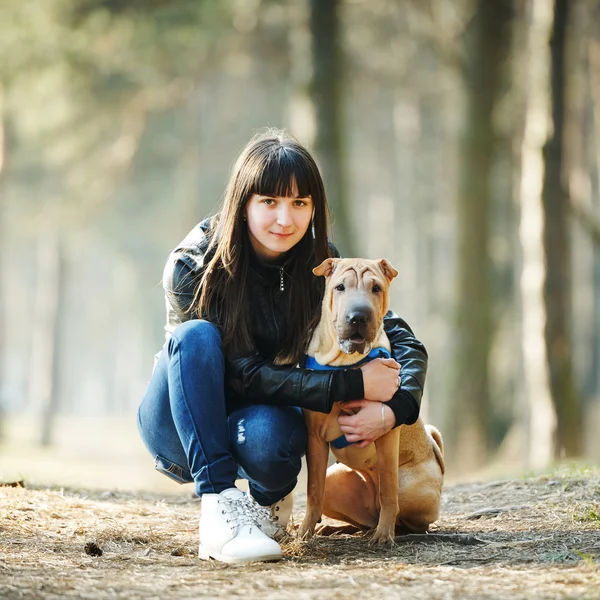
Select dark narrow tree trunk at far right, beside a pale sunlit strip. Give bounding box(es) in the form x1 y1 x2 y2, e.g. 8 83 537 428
542 0 582 457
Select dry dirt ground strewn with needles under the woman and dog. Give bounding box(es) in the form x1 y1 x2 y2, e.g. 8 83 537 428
0 469 600 600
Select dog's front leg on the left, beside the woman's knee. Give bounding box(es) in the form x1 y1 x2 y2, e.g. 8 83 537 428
298 431 329 539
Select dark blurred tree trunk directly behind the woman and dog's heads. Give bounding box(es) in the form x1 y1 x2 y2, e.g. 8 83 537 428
309 0 354 256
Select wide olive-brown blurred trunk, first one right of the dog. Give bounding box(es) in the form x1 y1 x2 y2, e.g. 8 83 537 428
446 0 512 469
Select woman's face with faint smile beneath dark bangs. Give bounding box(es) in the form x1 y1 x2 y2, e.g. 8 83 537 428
245 189 313 261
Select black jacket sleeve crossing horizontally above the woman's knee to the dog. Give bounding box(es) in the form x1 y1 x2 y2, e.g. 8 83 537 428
227 354 364 413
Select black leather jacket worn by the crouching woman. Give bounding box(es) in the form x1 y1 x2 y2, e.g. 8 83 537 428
163 219 427 426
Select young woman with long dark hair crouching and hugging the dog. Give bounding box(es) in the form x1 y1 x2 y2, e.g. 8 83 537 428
138 131 427 563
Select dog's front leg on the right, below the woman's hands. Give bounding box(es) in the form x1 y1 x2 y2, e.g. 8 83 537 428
371 429 400 544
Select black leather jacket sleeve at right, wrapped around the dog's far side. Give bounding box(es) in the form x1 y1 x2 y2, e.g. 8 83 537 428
383 311 428 427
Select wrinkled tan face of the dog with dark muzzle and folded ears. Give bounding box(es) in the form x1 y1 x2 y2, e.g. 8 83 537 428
313 258 398 354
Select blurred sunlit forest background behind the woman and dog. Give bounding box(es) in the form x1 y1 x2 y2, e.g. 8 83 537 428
0 0 600 490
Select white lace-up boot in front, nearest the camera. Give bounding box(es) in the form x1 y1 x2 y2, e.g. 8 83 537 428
198 488 281 564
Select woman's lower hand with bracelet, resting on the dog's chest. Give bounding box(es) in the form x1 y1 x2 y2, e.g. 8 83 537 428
338 400 396 448
